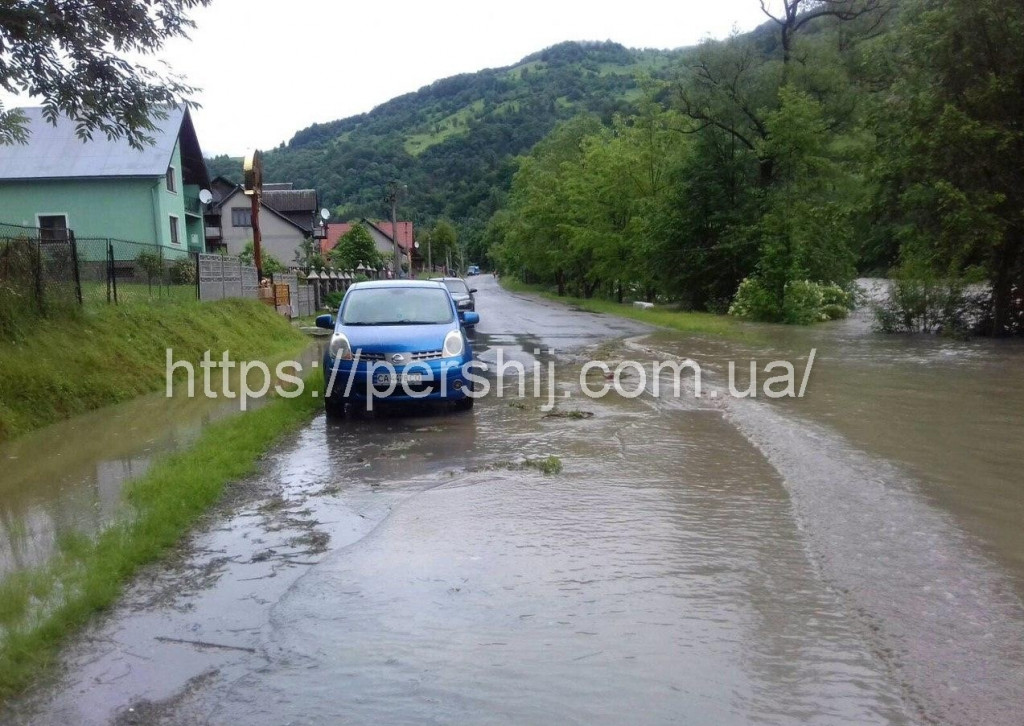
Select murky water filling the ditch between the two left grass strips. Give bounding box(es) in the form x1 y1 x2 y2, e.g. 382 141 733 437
0 345 318 578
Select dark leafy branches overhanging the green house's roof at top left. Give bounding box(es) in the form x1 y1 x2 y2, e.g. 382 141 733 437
0 0 210 147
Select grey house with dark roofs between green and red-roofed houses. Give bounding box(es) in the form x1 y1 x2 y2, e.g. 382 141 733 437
206 176 323 265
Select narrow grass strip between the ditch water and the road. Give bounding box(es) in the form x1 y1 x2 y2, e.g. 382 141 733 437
0 374 319 702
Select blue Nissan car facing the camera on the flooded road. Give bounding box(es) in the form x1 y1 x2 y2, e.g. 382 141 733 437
316 280 480 418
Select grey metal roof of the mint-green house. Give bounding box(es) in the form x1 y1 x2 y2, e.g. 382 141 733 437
0 108 210 185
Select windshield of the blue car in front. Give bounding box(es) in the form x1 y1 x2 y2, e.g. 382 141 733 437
341 287 452 326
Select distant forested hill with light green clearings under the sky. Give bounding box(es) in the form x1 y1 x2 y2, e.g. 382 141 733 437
210 42 700 239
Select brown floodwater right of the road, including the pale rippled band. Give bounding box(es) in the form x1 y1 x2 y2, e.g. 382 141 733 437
636 290 1024 724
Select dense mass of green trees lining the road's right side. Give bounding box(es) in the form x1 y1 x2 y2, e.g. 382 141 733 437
483 0 1024 335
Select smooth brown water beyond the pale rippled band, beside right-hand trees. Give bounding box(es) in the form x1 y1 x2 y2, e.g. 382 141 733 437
642 296 1024 598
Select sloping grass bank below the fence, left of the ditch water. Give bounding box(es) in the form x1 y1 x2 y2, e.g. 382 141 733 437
0 300 306 441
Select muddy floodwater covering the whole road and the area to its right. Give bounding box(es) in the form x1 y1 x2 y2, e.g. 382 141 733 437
2 277 1024 725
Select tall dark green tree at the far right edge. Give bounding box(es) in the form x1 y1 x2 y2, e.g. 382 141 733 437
890 0 1024 335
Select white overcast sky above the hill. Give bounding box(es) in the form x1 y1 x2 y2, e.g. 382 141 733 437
4 0 765 156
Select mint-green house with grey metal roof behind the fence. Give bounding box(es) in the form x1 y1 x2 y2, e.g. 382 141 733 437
0 109 210 259
